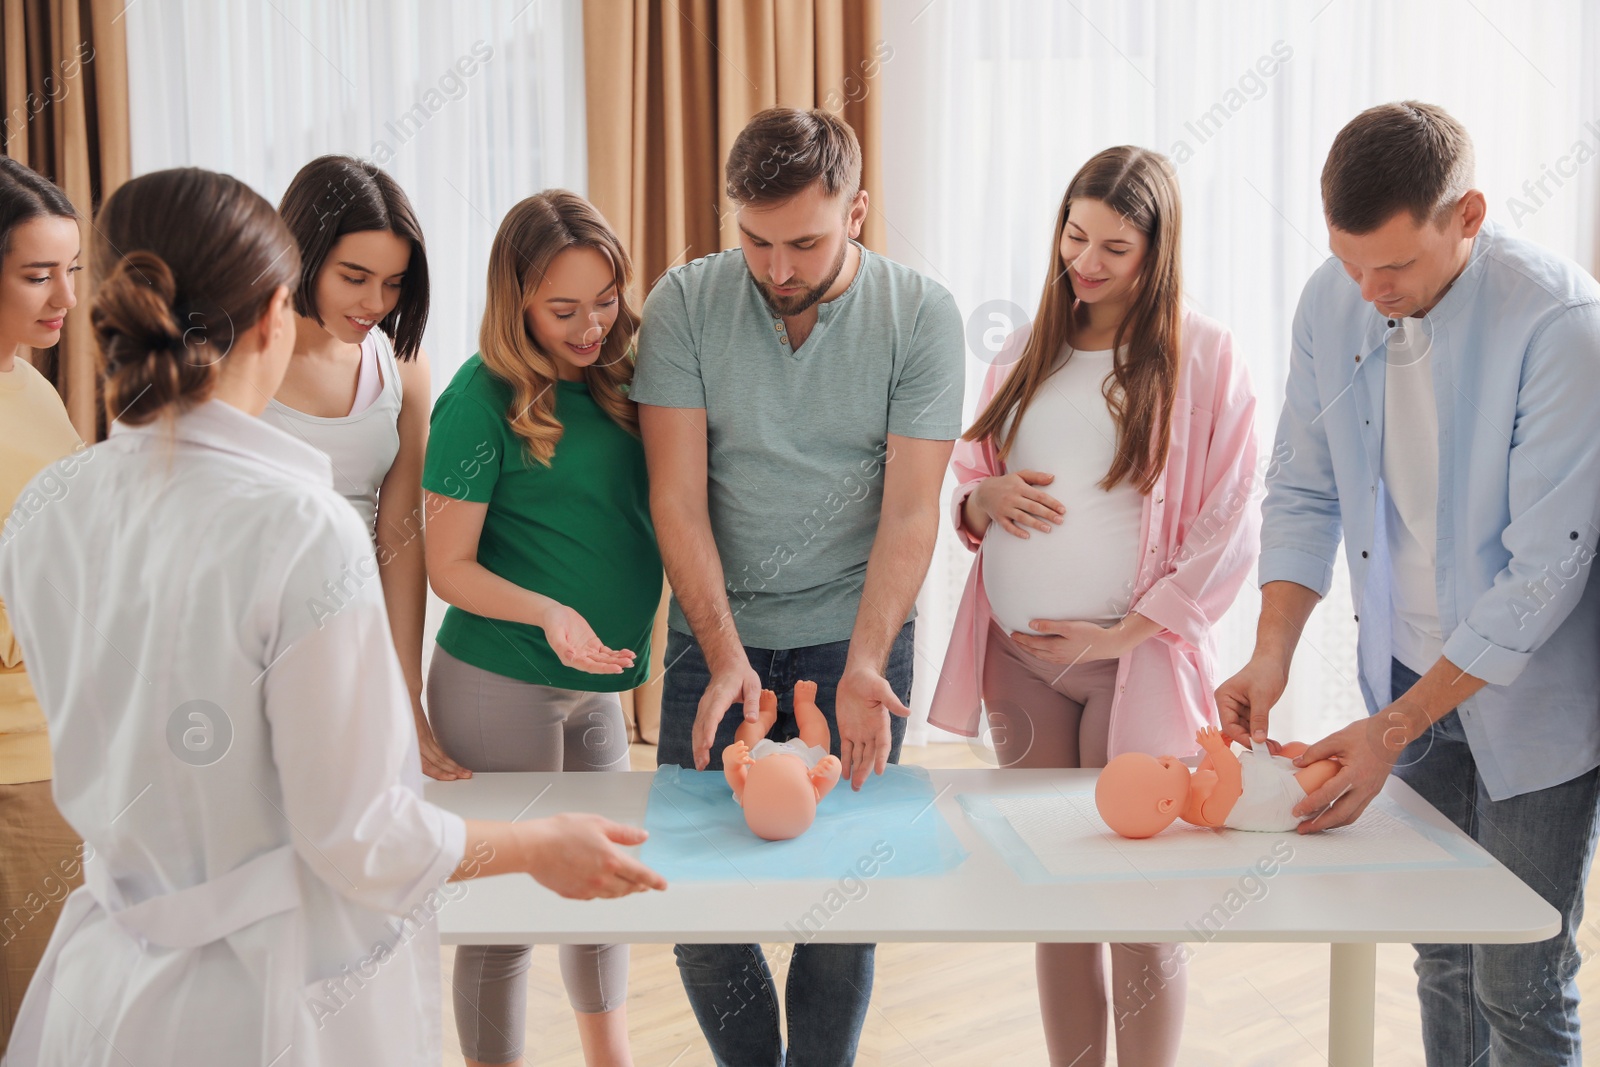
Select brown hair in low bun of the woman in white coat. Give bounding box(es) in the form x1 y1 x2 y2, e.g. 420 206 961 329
90 166 299 426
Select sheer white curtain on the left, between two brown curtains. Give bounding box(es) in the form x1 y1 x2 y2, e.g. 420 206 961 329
125 0 587 395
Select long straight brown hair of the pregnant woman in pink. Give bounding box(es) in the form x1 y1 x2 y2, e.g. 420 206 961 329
963 146 1182 493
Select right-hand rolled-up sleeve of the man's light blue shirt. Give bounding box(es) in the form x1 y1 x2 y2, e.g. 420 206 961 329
1443 304 1600 685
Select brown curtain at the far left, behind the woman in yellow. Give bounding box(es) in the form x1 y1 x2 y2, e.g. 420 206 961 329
0 0 131 442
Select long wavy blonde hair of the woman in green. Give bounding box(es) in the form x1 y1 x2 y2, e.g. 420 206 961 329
478 189 638 467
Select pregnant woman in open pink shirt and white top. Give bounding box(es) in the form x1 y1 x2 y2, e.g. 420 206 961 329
930 147 1259 1067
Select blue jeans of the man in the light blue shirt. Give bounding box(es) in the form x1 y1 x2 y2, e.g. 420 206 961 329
1392 661 1600 1067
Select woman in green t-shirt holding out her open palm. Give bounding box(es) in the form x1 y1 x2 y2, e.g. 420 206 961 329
422 190 661 1067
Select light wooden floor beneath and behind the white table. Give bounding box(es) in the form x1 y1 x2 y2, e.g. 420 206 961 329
443 744 1600 1067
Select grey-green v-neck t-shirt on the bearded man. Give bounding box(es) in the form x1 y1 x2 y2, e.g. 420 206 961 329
632 248 963 649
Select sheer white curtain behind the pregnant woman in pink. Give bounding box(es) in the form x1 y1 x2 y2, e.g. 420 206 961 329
874 0 1600 739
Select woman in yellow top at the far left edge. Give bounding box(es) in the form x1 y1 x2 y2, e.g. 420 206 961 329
0 157 83 1054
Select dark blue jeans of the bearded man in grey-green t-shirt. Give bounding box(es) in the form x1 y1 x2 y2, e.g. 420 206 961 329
656 622 915 1067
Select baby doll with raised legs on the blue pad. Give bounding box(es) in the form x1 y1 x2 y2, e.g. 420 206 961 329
722 681 840 841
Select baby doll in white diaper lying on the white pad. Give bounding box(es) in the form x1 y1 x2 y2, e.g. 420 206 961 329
1094 726 1339 838
